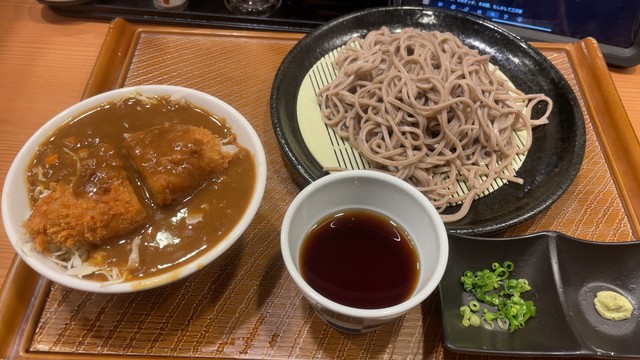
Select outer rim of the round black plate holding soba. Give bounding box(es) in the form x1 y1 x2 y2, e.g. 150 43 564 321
270 6 586 235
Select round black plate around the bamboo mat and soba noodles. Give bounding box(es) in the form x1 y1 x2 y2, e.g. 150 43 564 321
271 7 586 235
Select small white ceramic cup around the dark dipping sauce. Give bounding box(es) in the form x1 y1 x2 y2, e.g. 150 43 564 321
280 170 449 333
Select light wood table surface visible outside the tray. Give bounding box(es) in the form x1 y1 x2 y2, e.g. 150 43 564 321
0 0 640 292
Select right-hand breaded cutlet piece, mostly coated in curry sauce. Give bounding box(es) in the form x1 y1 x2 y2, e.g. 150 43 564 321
124 124 233 206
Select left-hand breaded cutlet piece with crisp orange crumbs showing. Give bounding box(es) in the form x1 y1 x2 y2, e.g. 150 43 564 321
24 144 147 252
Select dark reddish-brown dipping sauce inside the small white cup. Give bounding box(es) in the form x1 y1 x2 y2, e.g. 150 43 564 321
299 210 420 309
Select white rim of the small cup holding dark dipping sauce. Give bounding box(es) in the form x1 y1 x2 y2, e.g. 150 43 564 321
280 170 449 319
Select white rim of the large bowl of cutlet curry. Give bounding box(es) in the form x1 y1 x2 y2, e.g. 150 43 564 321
2 85 267 293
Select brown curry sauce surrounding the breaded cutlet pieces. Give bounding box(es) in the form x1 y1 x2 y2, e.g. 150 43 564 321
27 96 256 281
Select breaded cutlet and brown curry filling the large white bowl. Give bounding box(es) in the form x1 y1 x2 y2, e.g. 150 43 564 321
23 94 257 283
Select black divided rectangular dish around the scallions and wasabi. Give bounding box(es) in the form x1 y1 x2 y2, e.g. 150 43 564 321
439 232 640 357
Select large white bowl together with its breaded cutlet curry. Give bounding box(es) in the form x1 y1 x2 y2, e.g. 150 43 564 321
2 85 266 293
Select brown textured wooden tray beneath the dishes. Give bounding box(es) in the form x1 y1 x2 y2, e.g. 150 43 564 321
0 20 640 359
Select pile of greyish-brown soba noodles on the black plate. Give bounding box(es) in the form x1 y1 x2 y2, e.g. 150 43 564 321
318 28 552 222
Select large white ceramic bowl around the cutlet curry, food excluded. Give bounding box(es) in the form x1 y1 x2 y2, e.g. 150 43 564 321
2 85 267 293
